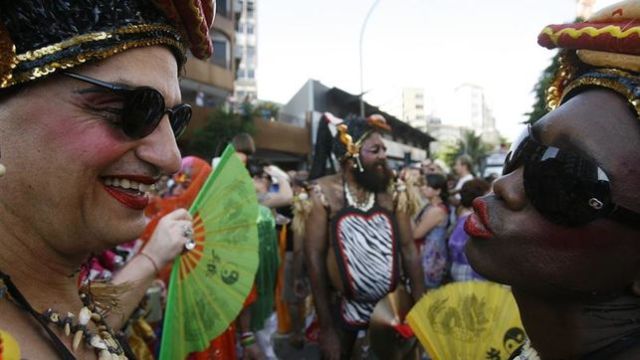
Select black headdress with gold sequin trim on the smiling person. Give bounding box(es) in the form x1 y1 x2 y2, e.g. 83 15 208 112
0 0 215 89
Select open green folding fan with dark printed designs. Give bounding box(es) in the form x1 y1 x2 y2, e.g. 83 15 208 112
160 146 258 360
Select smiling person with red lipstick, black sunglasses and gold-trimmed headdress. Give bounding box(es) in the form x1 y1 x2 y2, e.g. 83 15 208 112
0 0 215 359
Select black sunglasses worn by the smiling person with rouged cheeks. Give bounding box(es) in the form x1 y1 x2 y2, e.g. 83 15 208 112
62 72 191 139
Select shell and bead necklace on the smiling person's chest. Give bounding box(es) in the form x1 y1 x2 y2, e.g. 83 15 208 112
0 271 133 360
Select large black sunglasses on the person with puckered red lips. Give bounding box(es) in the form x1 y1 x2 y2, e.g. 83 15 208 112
502 126 640 228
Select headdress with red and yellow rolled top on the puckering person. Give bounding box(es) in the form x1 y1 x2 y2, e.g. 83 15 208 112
538 0 640 117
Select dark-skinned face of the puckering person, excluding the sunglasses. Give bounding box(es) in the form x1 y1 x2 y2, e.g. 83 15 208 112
466 90 640 296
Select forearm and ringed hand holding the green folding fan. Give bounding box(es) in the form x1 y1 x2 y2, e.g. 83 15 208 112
108 209 193 329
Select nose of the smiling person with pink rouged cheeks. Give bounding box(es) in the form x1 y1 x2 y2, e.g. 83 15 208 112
136 115 182 175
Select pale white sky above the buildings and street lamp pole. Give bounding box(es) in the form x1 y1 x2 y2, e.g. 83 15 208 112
256 0 616 140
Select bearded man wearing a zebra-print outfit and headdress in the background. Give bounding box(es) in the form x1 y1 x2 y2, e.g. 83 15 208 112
304 114 424 359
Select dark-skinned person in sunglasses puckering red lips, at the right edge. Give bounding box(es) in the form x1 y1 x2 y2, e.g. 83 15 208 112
465 0 640 360
